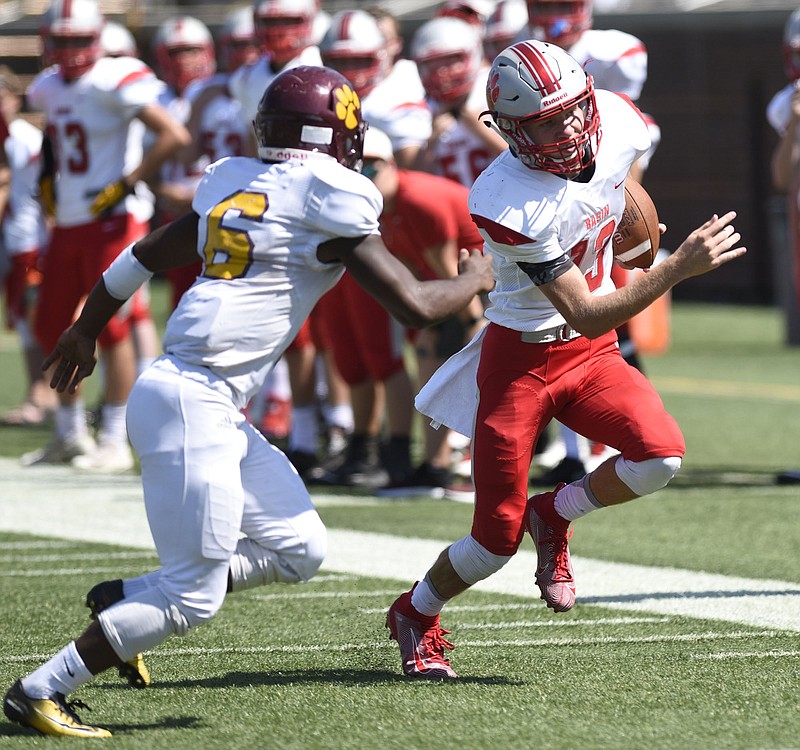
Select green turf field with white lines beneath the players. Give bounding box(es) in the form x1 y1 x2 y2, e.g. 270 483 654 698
0 290 800 750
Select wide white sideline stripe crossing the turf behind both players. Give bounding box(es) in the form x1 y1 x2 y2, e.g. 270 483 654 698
0 458 800 632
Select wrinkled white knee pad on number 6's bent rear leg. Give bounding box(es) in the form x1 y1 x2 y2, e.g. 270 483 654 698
230 517 328 591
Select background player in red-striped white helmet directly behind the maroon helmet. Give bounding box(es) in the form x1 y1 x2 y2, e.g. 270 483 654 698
320 10 431 168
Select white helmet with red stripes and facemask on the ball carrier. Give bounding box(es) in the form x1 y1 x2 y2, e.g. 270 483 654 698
483 40 601 175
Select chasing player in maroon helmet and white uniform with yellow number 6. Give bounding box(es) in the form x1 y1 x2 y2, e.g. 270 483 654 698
3 66 494 737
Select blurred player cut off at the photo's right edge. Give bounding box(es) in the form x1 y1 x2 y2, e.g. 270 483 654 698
767 8 800 484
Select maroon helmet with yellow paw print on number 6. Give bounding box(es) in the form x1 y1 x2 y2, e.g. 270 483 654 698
253 65 367 172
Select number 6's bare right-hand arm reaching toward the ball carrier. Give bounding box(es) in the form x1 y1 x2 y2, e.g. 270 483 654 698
317 235 494 328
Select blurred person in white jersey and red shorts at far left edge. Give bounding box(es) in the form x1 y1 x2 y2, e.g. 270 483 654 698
0 65 58 425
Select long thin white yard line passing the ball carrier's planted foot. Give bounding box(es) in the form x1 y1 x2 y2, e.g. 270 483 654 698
3 630 786 662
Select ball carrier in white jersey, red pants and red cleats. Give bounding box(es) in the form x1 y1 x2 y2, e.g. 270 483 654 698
387 41 745 678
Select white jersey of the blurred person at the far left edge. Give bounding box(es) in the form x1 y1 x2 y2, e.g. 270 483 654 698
2 118 47 255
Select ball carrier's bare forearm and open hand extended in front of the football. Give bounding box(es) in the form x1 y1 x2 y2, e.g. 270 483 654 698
539 211 747 338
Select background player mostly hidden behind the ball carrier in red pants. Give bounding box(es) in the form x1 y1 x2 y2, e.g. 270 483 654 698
527 0 661 485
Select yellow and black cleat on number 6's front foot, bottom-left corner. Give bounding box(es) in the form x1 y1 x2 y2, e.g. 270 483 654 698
3 680 111 738
